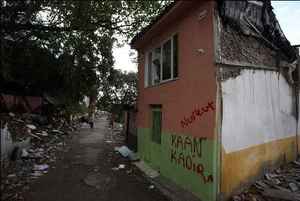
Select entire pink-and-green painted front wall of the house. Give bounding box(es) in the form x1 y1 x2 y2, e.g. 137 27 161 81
137 1 218 201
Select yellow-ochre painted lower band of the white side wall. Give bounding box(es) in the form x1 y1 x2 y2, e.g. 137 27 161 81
221 136 296 197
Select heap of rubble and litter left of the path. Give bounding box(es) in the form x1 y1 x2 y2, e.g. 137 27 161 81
0 113 77 201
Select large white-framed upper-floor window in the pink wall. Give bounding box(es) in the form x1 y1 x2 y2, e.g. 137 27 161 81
145 35 178 86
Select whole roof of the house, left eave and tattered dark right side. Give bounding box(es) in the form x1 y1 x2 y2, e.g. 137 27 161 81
130 0 297 62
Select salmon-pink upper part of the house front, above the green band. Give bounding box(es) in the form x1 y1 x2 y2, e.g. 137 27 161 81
137 1 217 138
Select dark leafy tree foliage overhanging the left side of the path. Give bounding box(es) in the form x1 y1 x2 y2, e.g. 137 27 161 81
0 0 170 112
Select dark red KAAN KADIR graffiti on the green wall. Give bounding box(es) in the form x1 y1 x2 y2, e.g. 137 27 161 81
171 135 213 184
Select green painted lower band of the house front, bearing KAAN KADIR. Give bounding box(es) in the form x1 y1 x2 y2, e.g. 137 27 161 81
138 128 218 201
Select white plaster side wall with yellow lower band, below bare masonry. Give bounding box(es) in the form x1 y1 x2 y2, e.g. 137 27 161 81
221 69 297 195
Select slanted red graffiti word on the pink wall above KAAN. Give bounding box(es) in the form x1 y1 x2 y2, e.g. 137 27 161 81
180 102 215 128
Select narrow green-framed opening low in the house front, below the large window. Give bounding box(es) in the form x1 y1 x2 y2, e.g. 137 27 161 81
152 106 162 144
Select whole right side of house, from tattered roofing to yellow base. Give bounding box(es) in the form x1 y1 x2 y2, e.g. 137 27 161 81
214 0 300 200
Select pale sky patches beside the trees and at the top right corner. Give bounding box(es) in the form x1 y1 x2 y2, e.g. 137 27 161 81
113 1 300 72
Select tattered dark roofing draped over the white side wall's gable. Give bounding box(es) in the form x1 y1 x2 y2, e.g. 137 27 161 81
218 0 297 63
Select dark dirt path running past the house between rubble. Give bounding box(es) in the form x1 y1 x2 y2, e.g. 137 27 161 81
25 119 167 201
